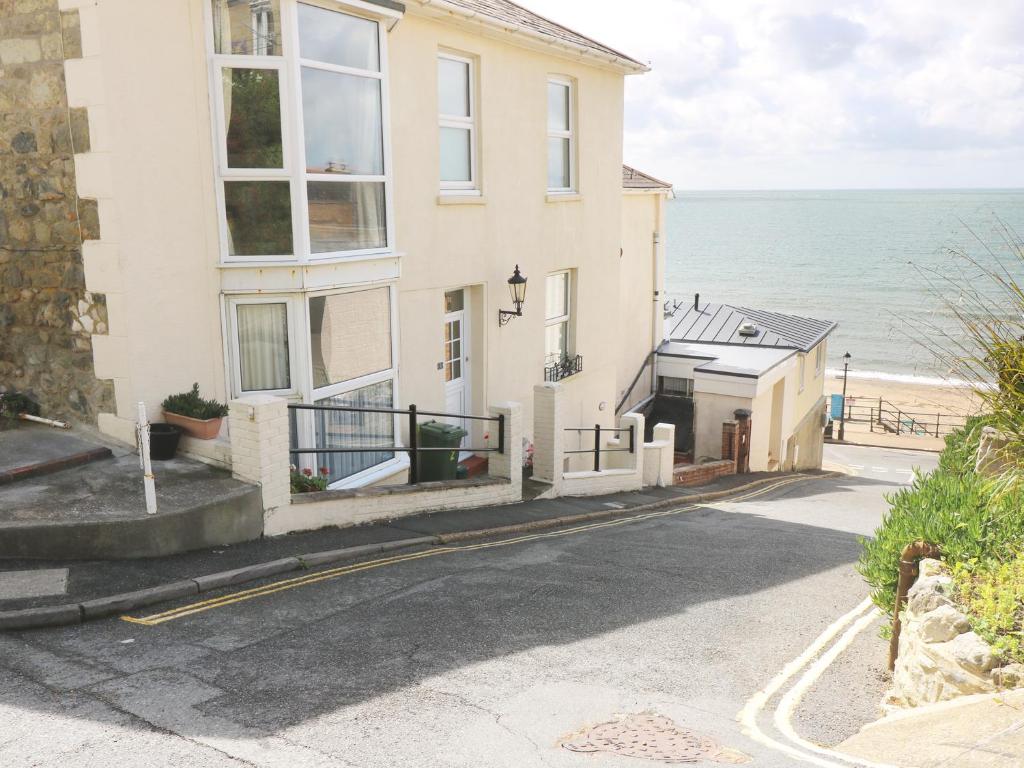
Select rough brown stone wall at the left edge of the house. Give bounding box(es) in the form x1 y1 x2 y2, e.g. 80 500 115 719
0 0 114 423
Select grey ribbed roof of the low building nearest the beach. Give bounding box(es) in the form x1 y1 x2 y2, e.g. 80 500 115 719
669 303 837 352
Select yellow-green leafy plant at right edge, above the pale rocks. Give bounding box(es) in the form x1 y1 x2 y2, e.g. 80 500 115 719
952 557 1024 663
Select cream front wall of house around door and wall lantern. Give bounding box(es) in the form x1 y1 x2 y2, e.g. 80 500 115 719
389 12 623 444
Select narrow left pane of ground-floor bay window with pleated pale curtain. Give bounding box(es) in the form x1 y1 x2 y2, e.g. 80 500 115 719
236 304 292 392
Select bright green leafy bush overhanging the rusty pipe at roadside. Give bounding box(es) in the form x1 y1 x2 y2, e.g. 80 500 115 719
857 425 1024 613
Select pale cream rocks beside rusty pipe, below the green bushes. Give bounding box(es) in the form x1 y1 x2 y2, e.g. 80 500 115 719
883 560 1024 709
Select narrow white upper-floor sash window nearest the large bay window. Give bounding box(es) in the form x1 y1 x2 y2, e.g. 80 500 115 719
437 53 477 190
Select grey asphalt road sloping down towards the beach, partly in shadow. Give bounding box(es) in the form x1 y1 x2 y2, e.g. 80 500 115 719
0 450 917 768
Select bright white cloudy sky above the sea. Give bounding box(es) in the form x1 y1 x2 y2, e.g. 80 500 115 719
517 0 1024 189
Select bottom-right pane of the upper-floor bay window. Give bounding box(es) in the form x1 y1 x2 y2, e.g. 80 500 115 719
306 181 387 253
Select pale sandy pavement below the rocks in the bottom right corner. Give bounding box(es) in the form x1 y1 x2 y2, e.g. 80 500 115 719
839 690 1024 768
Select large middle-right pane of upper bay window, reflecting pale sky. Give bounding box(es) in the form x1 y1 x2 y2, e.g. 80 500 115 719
302 67 384 176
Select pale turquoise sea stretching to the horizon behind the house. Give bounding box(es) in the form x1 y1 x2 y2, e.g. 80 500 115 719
666 189 1024 384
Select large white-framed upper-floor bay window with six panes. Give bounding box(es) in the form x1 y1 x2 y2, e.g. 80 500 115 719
211 0 391 261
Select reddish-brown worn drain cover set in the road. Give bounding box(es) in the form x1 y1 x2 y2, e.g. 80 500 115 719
562 715 750 763
